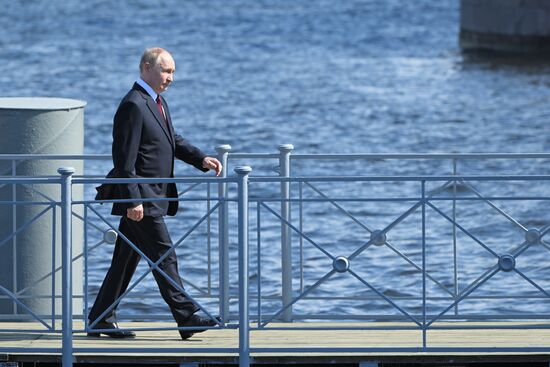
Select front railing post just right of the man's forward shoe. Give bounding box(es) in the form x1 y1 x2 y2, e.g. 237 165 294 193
235 166 252 367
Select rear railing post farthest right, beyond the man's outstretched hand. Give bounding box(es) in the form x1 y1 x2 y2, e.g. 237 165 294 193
279 144 294 321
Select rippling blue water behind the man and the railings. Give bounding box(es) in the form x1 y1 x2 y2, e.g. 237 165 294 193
0 0 550 322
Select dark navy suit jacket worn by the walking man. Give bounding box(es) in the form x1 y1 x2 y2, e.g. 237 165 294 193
106 83 208 216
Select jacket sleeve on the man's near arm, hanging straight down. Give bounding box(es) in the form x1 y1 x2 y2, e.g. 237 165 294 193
112 102 143 207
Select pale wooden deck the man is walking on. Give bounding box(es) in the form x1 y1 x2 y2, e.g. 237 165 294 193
0 322 550 365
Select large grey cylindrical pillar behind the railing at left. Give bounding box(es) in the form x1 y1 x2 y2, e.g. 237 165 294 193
0 98 86 321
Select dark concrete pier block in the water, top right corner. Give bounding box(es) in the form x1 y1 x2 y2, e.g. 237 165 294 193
460 0 550 53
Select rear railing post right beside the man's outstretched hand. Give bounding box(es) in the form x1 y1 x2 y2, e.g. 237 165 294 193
216 144 231 323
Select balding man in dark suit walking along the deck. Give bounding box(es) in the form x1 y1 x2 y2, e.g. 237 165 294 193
88 47 222 340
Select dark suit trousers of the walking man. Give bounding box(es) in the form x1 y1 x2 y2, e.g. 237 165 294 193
88 216 199 325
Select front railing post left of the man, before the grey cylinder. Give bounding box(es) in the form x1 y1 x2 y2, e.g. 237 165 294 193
57 167 74 367
